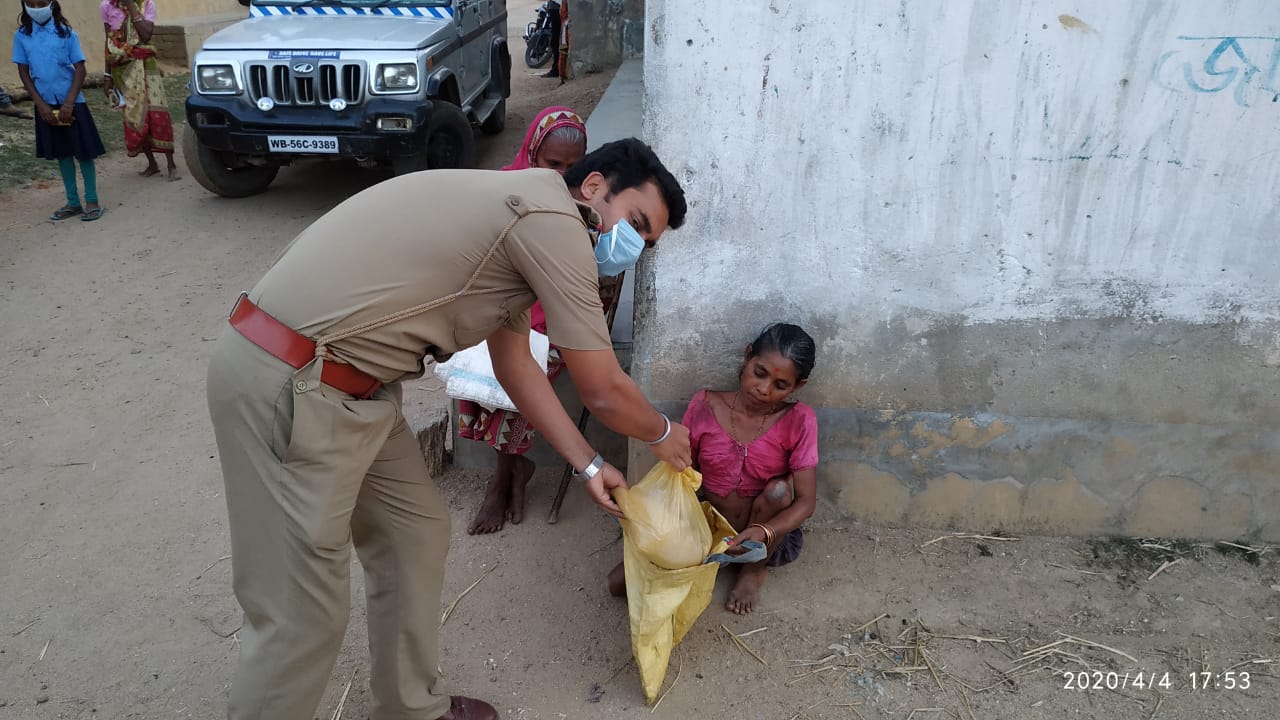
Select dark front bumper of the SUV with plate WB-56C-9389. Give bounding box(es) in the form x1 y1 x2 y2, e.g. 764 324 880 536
187 95 431 160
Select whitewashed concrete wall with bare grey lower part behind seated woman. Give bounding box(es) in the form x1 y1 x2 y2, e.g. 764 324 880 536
632 0 1280 539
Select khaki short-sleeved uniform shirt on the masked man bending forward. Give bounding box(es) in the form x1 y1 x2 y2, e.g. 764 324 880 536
250 170 612 383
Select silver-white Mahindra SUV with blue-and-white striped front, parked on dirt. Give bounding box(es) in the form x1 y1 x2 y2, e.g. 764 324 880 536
183 0 511 197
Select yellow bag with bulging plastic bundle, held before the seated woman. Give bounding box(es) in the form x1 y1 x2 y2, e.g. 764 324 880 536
613 462 736 703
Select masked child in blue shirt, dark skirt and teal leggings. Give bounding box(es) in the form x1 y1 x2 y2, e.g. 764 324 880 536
13 0 106 220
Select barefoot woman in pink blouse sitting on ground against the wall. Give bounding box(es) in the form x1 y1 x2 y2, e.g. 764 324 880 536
609 323 818 615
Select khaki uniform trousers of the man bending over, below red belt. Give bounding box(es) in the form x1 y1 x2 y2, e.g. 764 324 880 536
209 327 449 720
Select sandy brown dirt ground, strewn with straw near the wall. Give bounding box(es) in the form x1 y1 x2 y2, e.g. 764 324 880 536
0 0 1280 720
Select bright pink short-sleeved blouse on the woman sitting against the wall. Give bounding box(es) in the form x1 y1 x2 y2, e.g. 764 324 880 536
682 389 818 497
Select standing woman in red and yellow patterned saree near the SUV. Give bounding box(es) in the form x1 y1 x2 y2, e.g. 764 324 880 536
99 0 178 181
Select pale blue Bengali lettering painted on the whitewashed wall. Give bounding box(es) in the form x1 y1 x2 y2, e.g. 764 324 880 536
1151 35 1280 108
